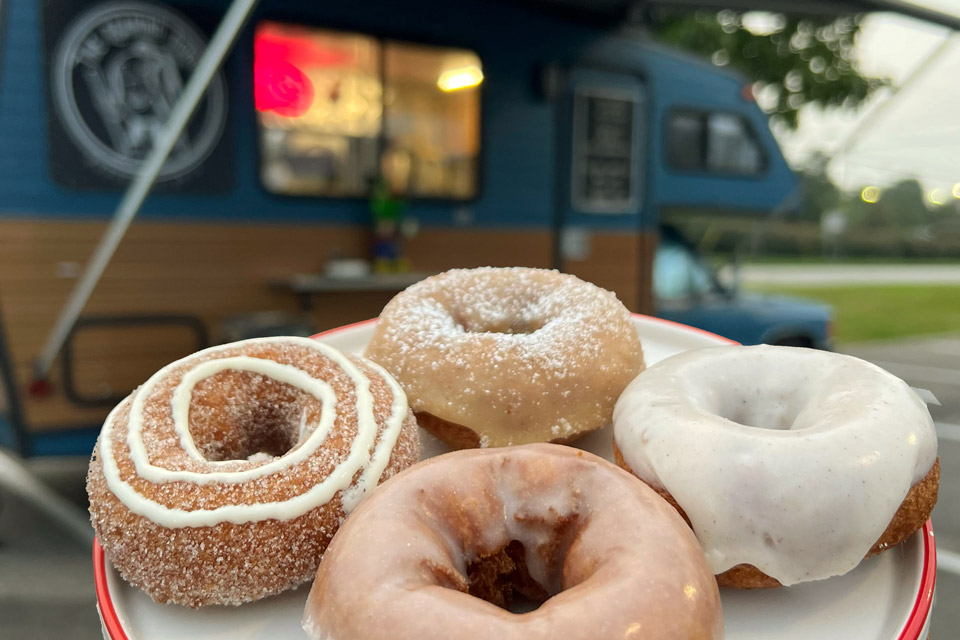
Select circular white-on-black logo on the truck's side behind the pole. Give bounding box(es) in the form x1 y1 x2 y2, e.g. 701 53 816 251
51 2 226 180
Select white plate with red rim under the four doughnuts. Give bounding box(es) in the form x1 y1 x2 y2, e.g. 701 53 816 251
94 316 936 640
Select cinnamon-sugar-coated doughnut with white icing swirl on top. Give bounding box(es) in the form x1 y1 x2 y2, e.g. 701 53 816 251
87 337 420 607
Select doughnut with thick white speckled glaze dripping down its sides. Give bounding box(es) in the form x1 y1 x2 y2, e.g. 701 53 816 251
613 345 940 588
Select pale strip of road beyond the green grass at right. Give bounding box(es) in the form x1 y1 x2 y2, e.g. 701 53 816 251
740 264 960 287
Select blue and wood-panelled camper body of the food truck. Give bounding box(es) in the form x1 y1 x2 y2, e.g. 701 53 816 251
0 0 826 455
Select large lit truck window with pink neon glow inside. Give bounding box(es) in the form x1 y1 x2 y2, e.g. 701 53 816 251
254 22 483 199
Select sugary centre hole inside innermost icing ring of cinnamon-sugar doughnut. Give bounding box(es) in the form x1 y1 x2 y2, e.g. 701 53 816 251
189 370 321 462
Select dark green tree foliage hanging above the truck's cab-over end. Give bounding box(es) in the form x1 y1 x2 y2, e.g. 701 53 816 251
651 10 889 128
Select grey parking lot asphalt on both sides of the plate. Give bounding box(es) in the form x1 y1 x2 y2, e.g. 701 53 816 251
0 335 960 640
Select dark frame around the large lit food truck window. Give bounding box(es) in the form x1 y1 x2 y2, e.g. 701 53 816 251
251 19 487 206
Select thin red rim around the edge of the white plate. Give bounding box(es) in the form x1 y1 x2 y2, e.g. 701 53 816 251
93 313 937 640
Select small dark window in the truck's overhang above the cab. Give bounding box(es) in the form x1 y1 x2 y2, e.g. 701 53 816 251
667 109 766 176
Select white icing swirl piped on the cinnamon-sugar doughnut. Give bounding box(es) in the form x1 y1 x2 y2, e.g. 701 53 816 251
100 337 407 528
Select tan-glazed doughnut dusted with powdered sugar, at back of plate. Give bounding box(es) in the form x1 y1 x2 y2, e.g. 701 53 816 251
366 267 643 449
